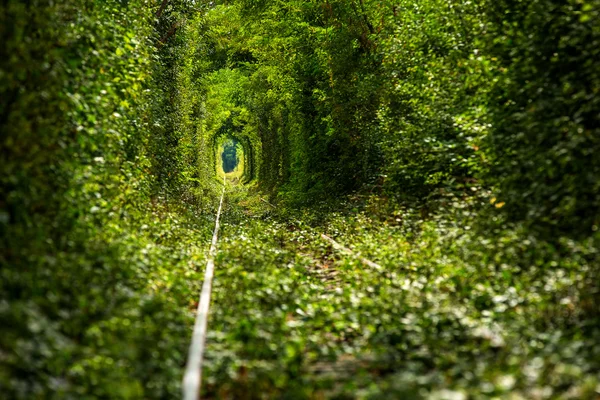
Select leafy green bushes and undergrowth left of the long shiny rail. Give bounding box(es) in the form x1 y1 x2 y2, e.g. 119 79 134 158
0 0 210 399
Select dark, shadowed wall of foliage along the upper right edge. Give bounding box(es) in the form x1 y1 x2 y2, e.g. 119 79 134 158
485 0 600 236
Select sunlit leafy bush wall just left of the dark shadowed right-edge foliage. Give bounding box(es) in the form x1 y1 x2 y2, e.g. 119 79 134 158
378 0 487 201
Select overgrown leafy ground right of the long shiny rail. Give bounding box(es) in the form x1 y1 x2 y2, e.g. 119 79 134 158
195 182 600 399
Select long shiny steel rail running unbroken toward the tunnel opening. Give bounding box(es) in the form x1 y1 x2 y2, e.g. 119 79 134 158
183 176 227 400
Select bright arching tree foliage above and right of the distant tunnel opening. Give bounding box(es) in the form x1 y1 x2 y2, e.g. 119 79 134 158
199 2 384 201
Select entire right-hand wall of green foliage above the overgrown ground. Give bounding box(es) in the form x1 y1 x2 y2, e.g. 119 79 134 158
202 0 599 235
